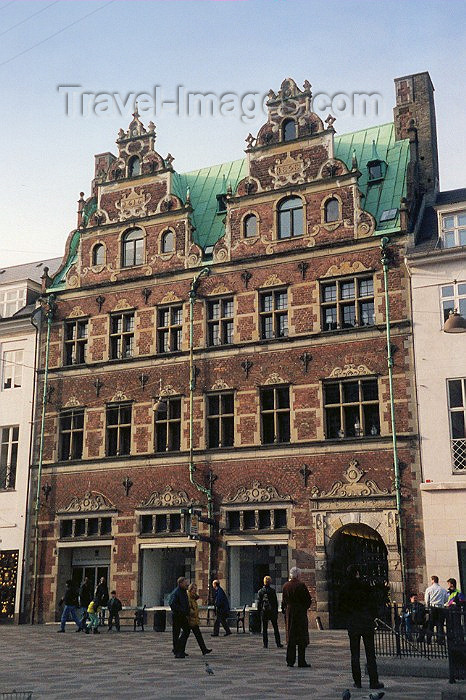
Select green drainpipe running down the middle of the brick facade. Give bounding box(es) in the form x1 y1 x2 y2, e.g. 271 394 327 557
189 267 214 597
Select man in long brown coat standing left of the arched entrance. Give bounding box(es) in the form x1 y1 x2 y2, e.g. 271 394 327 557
282 566 312 668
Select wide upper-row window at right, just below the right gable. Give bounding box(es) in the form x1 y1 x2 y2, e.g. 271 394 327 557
320 277 375 331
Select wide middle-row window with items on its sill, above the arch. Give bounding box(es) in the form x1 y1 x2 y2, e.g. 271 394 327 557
324 378 380 439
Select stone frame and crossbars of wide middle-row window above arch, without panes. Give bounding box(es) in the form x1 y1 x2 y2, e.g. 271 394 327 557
322 374 382 440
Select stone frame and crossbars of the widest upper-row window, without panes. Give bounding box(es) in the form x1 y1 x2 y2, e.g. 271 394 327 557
318 271 376 333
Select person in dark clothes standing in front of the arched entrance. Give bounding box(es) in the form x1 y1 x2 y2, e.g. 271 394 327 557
340 564 384 690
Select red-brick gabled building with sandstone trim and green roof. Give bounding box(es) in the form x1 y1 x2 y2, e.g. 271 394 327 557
28 73 437 626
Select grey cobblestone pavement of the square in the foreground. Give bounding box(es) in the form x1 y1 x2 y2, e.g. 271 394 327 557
0 624 464 700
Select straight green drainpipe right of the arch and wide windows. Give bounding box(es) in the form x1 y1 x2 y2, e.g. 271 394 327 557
380 236 406 601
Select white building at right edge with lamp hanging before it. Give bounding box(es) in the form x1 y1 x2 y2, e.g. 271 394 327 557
407 189 466 590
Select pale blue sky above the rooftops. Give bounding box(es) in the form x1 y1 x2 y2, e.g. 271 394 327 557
0 0 466 267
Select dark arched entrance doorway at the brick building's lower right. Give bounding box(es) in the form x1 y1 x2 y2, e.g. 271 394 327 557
328 524 389 629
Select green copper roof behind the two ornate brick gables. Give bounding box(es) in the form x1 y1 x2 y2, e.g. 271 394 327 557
51 123 409 289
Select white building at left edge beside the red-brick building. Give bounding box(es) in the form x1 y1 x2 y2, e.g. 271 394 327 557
0 258 61 622
